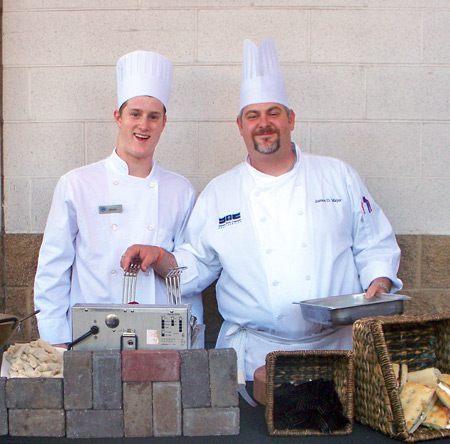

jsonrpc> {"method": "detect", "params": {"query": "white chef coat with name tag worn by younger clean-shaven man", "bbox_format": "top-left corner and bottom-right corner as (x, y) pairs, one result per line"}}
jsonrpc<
(34, 151), (203, 343)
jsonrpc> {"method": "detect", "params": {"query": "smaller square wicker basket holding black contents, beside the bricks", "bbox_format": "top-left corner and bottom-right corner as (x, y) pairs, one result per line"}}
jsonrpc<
(265, 351), (354, 436)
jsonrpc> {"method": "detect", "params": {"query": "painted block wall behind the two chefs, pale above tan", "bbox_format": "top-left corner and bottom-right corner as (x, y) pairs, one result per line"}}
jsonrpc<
(0, 0), (450, 340)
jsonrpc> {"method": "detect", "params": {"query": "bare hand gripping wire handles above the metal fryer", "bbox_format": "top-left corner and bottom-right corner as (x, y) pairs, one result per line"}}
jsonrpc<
(120, 244), (178, 277)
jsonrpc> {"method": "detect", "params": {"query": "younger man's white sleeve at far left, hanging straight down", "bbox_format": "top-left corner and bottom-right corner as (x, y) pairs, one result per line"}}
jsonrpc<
(34, 177), (78, 344)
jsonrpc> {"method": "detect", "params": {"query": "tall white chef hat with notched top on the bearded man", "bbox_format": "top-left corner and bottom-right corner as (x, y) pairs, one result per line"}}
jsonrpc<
(240, 38), (289, 110)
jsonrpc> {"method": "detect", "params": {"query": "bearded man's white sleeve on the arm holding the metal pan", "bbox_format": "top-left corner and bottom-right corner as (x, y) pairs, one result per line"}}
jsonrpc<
(347, 166), (403, 292)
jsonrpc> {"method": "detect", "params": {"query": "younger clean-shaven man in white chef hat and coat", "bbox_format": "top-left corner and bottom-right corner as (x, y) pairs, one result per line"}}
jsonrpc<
(34, 51), (202, 344)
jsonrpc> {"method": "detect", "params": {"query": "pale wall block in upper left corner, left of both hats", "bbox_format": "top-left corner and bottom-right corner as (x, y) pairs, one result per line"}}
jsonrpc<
(2, 11), (84, 65)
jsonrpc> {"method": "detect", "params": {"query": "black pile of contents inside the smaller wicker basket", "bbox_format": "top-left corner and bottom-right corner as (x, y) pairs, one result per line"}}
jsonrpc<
(273, 379), (349, 433)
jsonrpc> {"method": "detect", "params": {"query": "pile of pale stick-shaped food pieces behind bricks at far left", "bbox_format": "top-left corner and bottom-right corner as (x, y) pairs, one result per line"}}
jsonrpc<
(4, 339), (63, 378)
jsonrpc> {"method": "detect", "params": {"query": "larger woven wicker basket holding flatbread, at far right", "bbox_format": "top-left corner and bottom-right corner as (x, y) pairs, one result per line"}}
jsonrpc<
(353, 314), (450, 442)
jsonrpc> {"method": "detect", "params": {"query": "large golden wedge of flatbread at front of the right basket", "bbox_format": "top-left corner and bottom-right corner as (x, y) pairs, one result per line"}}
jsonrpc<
(400, 381), (437, 433)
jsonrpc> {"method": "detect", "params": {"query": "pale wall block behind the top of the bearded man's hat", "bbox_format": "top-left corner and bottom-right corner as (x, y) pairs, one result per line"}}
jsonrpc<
(198, 8), (309, 62)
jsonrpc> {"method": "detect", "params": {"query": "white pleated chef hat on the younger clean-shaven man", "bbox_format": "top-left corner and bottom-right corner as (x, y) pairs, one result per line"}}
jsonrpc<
(116, 51), (173, 109)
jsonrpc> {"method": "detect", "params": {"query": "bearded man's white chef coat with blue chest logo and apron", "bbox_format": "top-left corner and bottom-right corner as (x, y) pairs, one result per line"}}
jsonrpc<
(175, 146), (402, 380)
